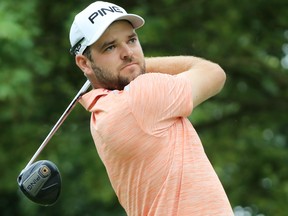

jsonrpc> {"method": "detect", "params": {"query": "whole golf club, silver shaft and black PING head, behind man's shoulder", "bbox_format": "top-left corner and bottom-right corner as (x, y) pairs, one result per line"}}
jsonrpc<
(17, 80), (91, 206)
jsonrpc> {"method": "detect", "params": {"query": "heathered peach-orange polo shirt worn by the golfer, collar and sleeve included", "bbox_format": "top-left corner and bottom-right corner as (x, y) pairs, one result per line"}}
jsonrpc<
(80, 73), (233, 216)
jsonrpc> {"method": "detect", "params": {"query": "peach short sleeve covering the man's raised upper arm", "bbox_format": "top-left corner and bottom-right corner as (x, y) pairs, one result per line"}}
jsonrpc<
(125, 73), (193, 135)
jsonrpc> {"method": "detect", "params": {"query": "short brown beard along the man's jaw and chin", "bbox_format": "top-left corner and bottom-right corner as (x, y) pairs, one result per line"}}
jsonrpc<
(91, 58), (146, 90)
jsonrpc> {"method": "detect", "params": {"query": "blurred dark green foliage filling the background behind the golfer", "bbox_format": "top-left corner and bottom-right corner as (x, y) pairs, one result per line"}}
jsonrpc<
(0, 0), (288, 216)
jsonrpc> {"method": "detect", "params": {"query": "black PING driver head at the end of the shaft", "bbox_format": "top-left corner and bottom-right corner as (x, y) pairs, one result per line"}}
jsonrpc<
(17, 160), (61, 206)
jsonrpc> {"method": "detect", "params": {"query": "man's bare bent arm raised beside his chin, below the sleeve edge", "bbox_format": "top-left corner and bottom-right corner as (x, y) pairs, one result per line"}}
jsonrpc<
(145, 56), (226, 107)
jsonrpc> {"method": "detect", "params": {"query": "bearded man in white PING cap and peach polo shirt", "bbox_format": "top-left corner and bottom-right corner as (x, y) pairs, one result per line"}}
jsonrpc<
(70, 2), (233, 216)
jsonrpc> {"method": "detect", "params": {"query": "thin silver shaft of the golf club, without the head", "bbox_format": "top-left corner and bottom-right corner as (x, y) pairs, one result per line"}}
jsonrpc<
(25, 80), (90, 168)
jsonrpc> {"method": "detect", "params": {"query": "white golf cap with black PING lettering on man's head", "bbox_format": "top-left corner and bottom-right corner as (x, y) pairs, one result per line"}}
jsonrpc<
(69, 1), (145, 55)
